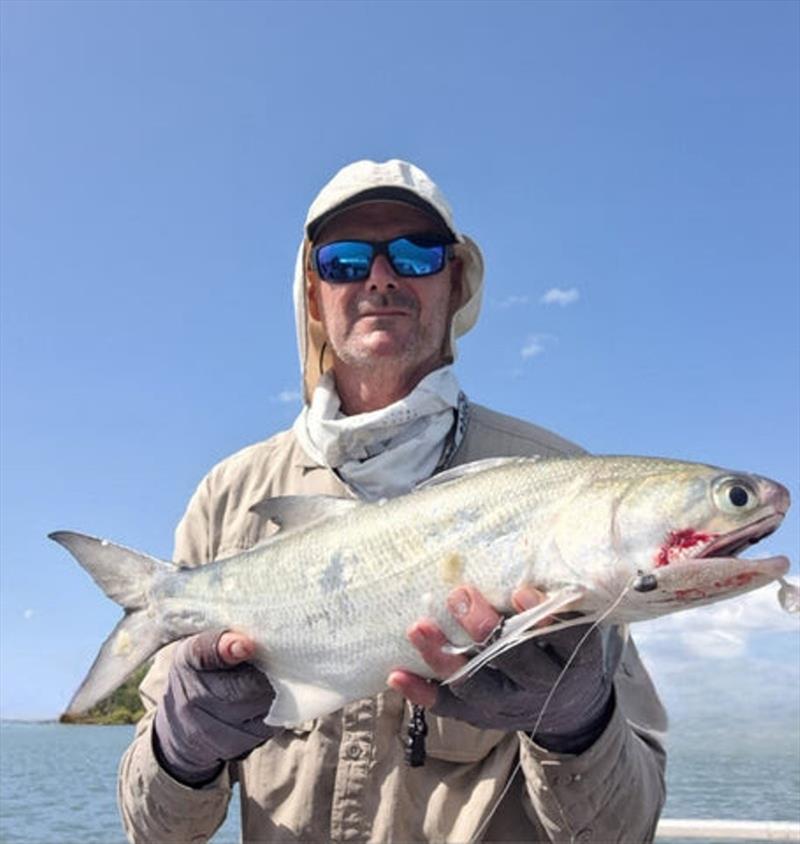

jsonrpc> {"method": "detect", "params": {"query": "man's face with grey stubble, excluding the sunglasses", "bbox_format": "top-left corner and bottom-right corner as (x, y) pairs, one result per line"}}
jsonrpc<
(308, 202), (461, 378)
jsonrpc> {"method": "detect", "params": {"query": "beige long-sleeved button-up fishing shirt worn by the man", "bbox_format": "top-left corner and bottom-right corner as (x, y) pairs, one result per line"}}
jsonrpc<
(119, 405), (666, 844)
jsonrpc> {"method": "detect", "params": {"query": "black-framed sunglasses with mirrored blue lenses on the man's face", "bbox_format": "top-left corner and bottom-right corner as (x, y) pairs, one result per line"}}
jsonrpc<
(312, 234), (454, 283)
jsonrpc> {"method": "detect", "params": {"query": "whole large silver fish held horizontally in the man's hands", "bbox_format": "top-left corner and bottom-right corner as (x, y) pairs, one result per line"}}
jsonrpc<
(51, 457), (798, 725)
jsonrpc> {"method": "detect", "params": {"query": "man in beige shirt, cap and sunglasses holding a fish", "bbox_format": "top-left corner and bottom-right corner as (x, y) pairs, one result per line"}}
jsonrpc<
(119, 161), (664, 842)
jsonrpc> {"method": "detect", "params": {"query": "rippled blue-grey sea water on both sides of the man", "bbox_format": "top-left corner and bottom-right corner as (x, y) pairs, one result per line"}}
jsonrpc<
(0, 719), (800, 844)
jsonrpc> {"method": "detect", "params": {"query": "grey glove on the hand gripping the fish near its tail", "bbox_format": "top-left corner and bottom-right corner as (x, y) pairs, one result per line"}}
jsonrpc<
(153, 630), (277, 787)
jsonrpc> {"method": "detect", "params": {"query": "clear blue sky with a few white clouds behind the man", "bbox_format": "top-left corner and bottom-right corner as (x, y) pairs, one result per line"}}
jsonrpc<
(0, 0), (800, 744)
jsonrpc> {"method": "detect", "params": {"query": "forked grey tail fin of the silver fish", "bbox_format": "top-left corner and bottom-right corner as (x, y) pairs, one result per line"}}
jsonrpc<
(50, 531), (172, 715)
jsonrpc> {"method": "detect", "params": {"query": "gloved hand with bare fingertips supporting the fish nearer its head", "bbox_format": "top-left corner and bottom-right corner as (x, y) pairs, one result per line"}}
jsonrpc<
(388, 586), (621, 753)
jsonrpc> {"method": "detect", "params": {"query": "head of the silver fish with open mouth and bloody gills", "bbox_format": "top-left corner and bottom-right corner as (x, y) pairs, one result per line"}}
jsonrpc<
(617, 464), (790, 620)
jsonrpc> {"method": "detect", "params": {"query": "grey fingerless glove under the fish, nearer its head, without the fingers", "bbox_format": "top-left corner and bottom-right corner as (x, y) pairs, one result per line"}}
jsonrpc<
(431, 625), (622, 753)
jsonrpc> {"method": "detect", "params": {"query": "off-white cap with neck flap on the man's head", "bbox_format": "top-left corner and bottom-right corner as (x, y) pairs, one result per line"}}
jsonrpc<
(294, 158), (483, 402)
